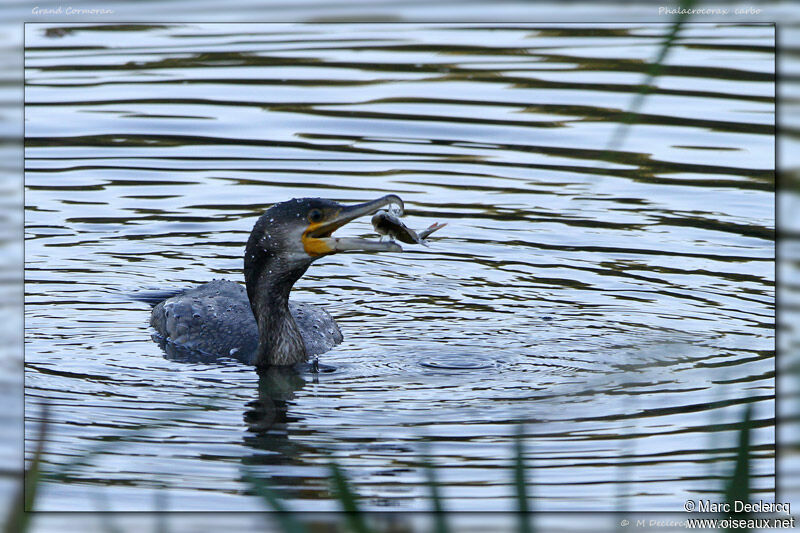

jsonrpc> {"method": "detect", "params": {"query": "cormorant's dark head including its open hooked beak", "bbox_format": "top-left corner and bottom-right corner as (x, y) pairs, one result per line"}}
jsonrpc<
(245, 194), (403, 269)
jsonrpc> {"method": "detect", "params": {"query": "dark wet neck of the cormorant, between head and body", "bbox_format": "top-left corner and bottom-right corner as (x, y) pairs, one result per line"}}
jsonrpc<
(244, 244), (308, 367)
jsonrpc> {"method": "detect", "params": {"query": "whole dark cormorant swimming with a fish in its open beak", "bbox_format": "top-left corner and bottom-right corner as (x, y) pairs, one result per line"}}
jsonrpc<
(150, 194), (403, 367)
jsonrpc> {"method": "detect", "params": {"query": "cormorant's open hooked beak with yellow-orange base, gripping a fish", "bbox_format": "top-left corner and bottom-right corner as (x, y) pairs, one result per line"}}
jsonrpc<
(302, 194), (404, 257)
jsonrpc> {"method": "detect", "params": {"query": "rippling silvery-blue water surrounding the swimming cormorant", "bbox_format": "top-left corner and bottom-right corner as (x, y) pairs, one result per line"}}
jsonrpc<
(25, 24), (775, 511)
